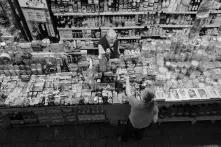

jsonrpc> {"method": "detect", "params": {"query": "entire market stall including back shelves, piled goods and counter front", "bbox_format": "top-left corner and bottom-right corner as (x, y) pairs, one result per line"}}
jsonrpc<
(0, 0), (221, 126)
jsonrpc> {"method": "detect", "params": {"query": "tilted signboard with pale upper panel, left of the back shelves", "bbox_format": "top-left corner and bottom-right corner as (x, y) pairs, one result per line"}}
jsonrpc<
(18, 0), (55, 40)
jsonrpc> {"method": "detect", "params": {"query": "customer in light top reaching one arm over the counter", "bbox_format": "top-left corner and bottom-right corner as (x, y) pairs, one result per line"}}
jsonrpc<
(119, 76), (158, 141)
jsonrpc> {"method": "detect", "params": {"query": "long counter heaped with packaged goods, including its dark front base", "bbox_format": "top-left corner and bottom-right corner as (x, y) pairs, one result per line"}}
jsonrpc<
(0, 33), (221, 126)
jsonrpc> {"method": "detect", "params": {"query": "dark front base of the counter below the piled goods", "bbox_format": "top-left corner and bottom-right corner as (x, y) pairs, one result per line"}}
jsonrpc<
(0, 99), (221, 127)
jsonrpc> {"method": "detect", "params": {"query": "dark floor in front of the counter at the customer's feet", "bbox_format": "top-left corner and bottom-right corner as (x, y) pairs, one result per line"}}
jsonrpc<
(0, 122), (221, 147)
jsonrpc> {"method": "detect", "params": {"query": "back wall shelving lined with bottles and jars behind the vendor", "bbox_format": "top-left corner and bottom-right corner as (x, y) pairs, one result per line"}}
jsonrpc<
(51, 0), (221, 47)
